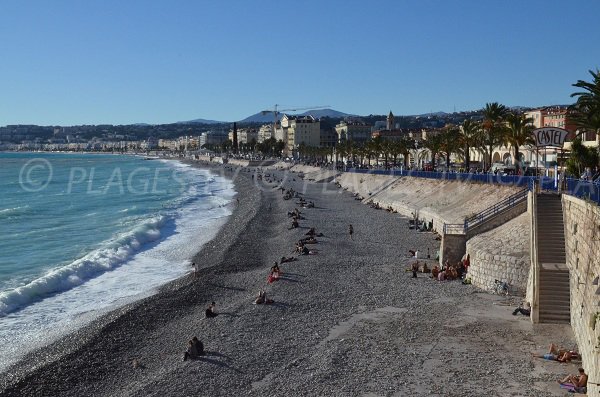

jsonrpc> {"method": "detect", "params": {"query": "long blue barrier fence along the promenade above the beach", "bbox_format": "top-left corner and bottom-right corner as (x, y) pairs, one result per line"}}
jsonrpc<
(347, 168), (600, 205)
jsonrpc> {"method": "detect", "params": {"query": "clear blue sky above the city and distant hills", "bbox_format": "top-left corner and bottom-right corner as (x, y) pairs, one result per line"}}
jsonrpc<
(0, 0), (600, 126)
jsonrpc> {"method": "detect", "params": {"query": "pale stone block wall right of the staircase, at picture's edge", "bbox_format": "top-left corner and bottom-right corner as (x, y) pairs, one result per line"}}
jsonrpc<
(562, 194), (600, 396)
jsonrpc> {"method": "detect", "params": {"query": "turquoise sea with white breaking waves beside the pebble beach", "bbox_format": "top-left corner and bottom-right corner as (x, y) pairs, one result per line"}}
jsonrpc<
(0, 153), (236, 371)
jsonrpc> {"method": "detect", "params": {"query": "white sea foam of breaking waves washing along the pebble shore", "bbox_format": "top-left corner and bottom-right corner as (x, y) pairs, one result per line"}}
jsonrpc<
(0, 162), (236, 371)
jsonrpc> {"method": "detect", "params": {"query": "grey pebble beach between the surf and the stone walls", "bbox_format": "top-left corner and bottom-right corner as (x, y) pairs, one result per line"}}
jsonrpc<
(0, 162), (571, 396)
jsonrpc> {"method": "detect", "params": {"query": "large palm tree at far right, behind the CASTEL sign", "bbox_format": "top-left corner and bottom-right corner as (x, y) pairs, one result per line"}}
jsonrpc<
(569, 69), (600, 134)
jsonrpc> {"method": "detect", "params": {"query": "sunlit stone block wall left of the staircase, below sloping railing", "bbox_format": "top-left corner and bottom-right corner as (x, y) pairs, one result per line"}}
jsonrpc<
(467, 213), (530, 296)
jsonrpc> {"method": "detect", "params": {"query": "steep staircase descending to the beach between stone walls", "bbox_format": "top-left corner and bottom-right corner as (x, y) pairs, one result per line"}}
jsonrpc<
(536, 194), (571, 324)
